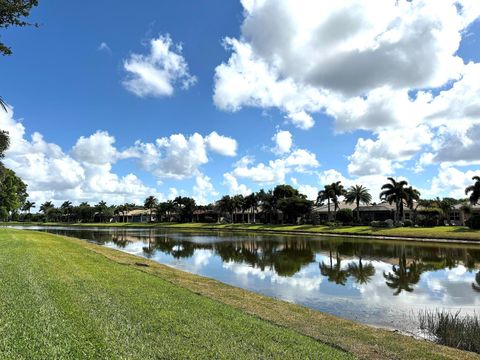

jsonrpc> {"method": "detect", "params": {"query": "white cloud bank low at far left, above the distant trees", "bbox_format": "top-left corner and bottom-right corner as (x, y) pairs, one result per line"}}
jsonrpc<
(0, 109), (162, 203)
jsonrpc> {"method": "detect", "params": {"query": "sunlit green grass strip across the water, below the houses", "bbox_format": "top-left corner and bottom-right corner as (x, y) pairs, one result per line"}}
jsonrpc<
(3, 219), (480, 241)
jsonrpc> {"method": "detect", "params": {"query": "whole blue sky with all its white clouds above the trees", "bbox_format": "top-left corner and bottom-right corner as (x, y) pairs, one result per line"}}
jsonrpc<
(0, 0), (480, 203)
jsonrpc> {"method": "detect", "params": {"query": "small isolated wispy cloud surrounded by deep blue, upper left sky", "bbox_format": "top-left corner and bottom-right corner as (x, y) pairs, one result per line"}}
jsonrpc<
(123, 34), (197, 97)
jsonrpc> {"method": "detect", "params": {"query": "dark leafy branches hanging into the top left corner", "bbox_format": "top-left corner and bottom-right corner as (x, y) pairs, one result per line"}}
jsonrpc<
(0, 0), (38, 55)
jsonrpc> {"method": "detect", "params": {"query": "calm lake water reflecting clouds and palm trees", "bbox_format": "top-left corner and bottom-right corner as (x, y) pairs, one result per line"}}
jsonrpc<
(11, 227), (480, 332)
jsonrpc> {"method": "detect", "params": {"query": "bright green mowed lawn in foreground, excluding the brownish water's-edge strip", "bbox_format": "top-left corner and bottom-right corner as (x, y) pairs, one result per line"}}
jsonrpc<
(0, 229), (354, 359)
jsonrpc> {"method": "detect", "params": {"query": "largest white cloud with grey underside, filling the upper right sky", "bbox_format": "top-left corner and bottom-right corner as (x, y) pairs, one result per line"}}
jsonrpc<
(214, 0), (480, 176)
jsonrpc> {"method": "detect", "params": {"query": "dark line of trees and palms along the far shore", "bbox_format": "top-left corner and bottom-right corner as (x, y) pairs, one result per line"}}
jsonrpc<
(10, 176), (480, 229)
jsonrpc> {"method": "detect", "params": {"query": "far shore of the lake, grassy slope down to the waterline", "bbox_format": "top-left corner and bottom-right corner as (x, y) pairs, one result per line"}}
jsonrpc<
(0, 222), (480, 244)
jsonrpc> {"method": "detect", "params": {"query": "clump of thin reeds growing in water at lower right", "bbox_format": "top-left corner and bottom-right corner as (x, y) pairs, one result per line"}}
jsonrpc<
(418, 310), (480, 353)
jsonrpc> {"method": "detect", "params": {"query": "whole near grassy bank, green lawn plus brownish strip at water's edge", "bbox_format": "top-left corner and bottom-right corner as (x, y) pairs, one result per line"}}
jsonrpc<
(0, 229), (478, 359)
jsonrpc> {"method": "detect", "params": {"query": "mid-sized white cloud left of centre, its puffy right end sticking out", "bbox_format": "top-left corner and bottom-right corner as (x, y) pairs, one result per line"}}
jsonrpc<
(132, 132), (237, 180)
